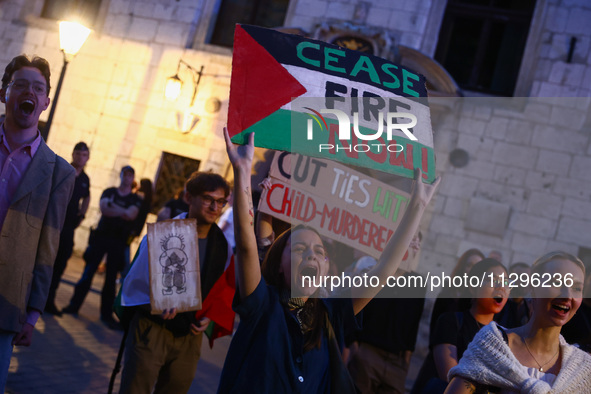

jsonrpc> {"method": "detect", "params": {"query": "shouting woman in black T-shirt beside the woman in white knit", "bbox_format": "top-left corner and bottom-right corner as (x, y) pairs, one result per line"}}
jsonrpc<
(411, 258), (509, 393)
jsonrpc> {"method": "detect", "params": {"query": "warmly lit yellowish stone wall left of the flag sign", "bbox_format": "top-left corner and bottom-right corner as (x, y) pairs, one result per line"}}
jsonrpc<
(0, 0), (236, 246)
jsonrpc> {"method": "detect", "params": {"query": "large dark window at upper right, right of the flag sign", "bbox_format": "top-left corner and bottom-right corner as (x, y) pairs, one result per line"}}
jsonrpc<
(435, 0), (535, 96)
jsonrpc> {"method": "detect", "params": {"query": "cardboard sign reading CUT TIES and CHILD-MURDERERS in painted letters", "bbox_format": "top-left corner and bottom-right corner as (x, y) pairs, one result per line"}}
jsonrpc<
(259, 152), (416, 271)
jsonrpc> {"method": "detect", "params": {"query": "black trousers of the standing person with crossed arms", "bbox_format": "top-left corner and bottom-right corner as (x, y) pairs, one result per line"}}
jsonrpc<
(70, 234), (127, 319)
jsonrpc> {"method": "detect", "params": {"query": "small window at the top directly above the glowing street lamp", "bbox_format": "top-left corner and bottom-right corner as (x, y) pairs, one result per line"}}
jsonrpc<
(41, 0), (101, 27)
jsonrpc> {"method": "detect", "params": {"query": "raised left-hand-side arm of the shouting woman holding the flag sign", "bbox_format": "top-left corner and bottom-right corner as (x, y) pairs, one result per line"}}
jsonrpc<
(224, 127), (261, 298)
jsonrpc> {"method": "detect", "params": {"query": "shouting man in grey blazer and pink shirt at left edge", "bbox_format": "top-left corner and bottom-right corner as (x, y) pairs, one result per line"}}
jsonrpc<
(0, 55), (75, 391)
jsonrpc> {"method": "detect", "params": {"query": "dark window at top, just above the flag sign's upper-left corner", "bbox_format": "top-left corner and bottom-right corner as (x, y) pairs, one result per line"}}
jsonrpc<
(206, 0), (289, 48)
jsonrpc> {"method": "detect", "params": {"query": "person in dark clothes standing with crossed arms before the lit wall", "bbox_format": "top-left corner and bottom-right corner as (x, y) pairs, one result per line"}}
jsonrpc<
(62, 166), (141, 330)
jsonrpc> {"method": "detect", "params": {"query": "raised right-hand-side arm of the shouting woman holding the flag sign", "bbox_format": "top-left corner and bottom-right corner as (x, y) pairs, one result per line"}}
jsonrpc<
(351, 168), (441, 313)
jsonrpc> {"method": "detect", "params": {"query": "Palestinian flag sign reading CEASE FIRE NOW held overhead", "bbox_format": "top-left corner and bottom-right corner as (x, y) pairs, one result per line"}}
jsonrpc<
(228, 25), (435, 182)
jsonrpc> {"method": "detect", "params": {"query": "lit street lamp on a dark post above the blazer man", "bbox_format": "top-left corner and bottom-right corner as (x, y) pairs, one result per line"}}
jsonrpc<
(41, 22), (91, 141)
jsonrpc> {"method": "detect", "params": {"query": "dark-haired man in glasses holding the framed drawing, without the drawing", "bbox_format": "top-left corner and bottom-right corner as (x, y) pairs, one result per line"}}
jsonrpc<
(119, 172), (234, 393)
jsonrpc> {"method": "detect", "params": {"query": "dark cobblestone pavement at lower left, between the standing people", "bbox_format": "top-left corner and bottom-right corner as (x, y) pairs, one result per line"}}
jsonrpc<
(5, 257), (230, 394)
